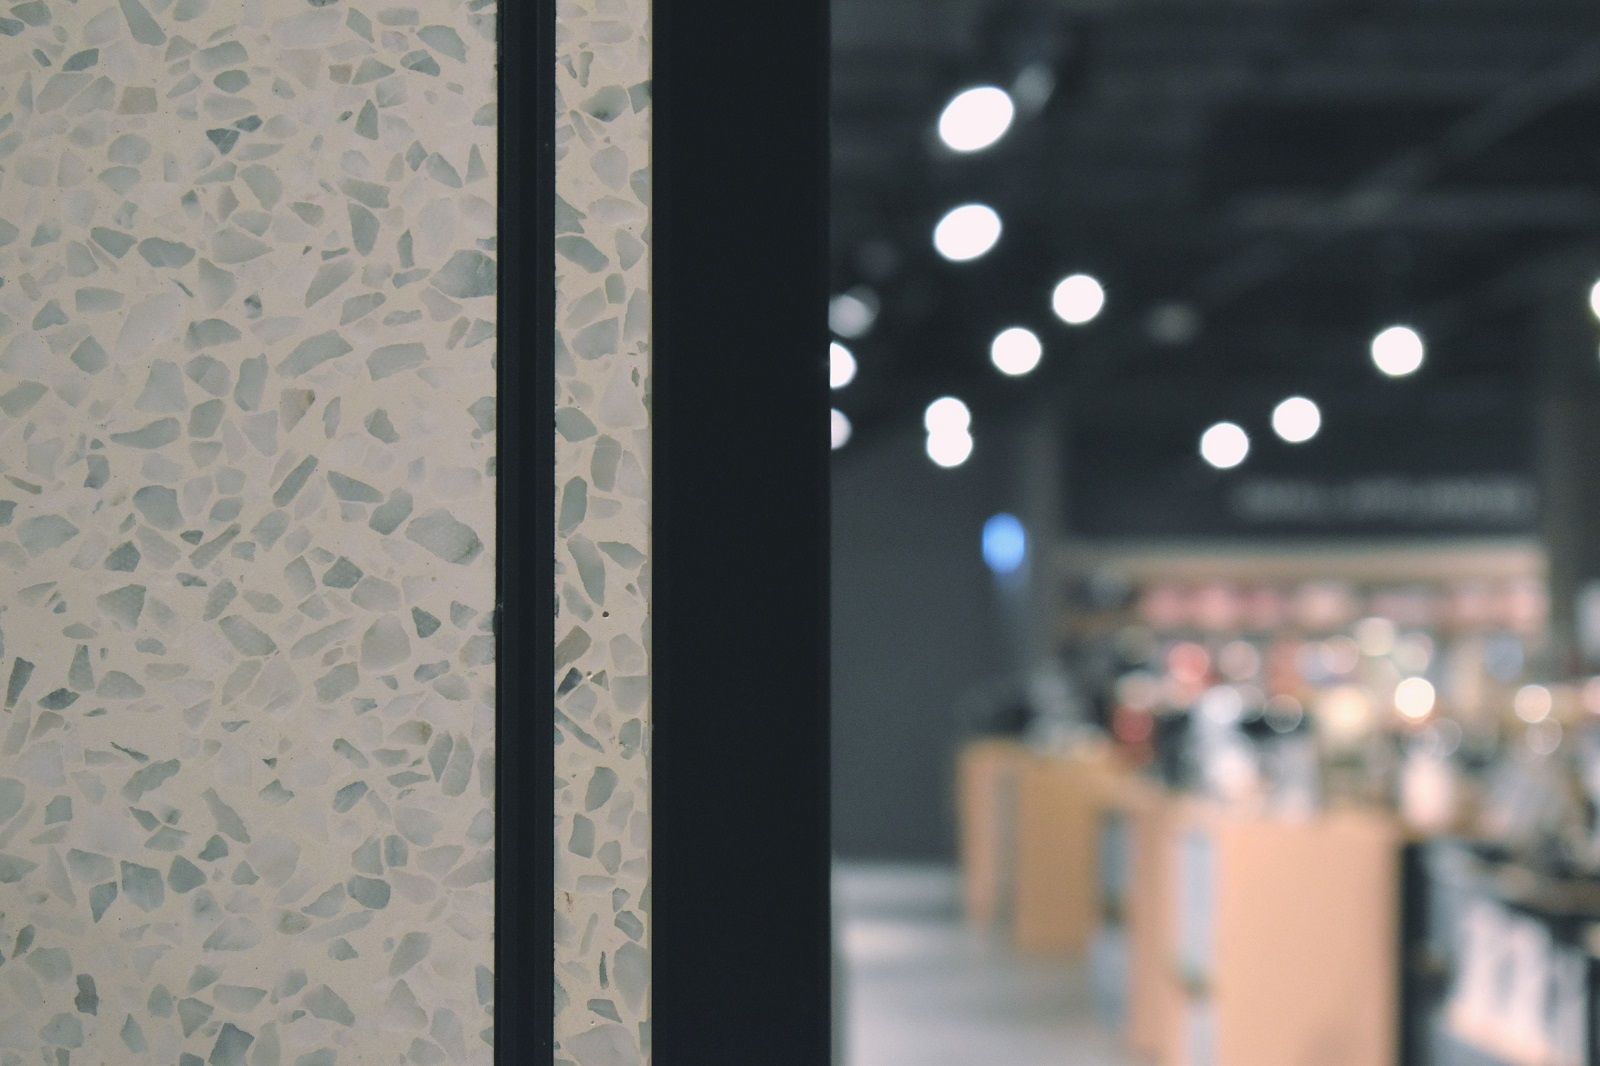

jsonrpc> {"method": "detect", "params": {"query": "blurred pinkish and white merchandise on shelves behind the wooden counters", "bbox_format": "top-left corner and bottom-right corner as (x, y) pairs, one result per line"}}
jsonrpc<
(1062, 560), (1600, 860)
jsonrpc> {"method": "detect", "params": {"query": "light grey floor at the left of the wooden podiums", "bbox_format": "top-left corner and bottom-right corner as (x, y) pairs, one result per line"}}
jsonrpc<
(834, 864), (1133, 1066)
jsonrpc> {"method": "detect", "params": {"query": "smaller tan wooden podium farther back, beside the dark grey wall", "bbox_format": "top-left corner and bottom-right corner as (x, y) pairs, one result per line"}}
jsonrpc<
(958, 741), (1115, 954)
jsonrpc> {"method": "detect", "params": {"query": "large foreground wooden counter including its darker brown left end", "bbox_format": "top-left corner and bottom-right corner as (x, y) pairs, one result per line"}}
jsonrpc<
(1093, 793), (1405, 1066)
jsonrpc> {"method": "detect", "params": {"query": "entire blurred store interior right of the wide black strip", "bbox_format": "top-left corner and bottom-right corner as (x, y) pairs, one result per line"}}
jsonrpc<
(829, 0), (1600, 1066)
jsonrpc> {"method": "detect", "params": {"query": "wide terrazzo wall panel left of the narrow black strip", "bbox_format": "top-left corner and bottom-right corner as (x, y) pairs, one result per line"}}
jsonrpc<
(0, 0), (496, 1066)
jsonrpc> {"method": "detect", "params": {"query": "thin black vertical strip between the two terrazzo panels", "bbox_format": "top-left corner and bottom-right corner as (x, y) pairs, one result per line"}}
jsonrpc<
(494, 0), (555, 1049)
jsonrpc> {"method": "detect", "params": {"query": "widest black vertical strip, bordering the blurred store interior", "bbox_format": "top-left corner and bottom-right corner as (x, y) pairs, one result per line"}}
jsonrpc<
(651, 0), (830, 1066)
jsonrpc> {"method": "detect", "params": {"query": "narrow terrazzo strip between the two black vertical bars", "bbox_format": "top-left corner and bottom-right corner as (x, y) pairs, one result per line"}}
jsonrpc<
(555, 0), (651, 1066)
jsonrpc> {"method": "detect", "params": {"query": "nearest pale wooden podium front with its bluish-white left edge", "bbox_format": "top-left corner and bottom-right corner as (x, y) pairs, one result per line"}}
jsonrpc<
(1144, 800), (1403, 1066)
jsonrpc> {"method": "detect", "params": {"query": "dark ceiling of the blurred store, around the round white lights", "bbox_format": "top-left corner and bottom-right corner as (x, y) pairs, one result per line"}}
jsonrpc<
(832, 0), (1600, 459)
